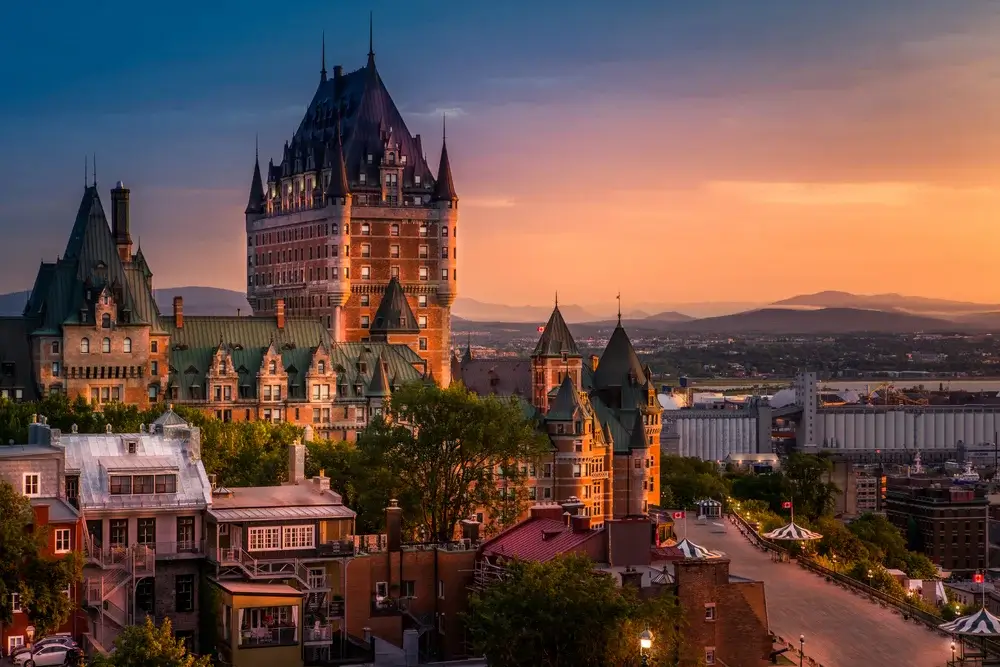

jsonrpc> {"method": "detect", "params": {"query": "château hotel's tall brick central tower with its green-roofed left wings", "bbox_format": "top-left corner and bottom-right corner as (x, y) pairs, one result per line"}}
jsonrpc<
(0, 39), (458, 440)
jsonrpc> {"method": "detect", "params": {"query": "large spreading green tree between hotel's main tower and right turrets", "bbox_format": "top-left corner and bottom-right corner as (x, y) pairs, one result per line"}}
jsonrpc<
(358, 383), (550, 541)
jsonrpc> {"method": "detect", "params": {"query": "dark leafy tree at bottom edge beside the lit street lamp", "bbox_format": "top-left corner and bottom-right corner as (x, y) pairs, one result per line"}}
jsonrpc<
(465, 554), (680, 667)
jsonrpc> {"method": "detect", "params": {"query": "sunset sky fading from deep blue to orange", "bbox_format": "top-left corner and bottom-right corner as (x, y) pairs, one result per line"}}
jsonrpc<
(0, 0), (1000, 305)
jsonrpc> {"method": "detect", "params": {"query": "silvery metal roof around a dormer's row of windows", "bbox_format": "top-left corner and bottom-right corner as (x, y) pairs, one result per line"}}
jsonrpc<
(61, 433), (212, 512)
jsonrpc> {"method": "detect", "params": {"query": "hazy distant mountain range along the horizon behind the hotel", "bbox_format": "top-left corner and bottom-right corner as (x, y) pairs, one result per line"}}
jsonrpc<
(0, 287), (1000, 336)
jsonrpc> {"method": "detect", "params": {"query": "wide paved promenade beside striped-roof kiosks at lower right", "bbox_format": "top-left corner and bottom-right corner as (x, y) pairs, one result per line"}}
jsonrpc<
(677, 521), (951, 667)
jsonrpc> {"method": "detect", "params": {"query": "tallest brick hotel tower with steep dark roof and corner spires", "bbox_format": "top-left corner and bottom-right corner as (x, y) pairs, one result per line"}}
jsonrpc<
(246, 30), (458, 386)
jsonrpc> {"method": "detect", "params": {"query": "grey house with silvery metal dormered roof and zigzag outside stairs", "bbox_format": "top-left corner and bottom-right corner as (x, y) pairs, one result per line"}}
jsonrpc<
(59, 411), (211, 647)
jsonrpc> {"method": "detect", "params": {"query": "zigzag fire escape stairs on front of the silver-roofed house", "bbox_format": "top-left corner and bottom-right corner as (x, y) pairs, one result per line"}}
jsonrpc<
(83, 532), (156, 642)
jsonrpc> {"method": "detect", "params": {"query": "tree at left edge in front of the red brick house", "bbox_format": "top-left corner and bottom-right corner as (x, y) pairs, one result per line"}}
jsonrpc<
(0, 480), (83, 637)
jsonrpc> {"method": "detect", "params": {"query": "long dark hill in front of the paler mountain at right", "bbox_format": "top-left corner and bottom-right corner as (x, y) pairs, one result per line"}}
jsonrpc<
(669, 308), (970, 334)
